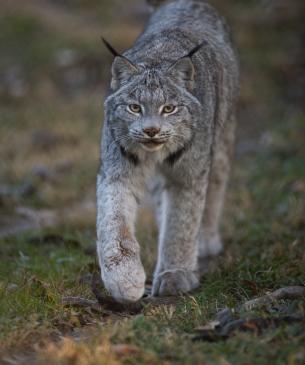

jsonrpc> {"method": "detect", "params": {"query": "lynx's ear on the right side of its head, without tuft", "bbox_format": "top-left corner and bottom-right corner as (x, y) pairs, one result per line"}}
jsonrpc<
(167, 56), (195, 88)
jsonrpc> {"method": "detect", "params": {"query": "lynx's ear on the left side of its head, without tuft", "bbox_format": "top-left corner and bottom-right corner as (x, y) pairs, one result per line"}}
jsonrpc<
(111, 55), (138, 90)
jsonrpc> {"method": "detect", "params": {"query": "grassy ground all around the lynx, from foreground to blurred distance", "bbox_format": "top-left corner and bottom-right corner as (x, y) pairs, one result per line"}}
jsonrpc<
(0, 0), (305, 365)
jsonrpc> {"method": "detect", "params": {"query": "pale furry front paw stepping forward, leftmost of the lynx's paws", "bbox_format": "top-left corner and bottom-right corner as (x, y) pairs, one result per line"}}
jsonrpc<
(101, 245), (146, 303)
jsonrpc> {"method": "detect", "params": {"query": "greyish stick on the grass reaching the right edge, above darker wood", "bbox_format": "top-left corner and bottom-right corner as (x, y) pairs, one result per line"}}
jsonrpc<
(240, 286), (305, 311)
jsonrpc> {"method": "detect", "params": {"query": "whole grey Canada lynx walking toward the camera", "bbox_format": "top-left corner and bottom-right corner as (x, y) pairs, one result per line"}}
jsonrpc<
(97, 0), (238, 302)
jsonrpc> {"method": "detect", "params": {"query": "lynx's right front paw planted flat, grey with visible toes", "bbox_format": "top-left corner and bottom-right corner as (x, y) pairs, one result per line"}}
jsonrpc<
(152, 269), (199, 296)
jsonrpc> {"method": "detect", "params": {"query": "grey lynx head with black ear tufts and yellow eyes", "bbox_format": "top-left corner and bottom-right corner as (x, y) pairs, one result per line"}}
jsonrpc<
(105, 42), (201, 154)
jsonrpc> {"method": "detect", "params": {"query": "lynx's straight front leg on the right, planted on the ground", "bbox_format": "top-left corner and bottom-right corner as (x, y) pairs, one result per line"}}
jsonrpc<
(152, 184), (206, 295)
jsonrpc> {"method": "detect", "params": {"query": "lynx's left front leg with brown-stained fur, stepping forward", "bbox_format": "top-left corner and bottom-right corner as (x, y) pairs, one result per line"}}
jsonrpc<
(97, 176), (145, 302)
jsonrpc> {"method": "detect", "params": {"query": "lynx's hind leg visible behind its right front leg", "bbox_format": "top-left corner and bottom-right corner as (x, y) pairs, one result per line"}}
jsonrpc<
(199, 118), (235, 258)
